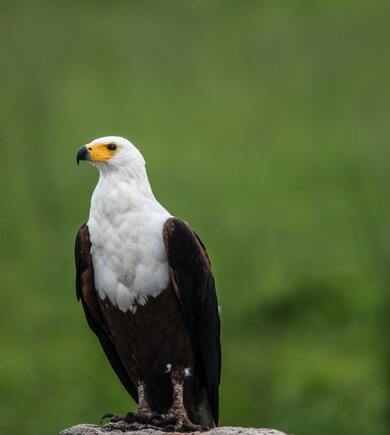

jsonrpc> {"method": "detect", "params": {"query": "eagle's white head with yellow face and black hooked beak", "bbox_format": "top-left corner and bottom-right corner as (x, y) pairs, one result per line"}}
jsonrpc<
(77, 136), (145, 170)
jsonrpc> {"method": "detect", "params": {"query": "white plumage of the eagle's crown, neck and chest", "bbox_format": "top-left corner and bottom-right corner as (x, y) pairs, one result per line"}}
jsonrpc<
(88, 137), (171, 312)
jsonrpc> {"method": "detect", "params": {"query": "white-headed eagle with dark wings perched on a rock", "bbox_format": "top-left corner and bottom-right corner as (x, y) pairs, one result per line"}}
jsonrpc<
(75, 136), (221, 431)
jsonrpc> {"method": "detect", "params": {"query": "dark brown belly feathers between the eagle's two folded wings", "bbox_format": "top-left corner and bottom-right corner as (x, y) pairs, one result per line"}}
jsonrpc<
(99, 287), (204, 422)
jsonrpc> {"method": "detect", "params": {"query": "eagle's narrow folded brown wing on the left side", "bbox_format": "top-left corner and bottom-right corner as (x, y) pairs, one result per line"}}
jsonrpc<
(75, 225), (138, 402)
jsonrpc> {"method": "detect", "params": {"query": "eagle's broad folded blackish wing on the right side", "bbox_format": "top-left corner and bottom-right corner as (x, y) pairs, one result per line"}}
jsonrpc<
(164, 218), (221, 425)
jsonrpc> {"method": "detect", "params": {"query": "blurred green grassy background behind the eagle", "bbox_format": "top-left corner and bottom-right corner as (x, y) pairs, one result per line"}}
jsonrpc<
(0, 0), (390, 435)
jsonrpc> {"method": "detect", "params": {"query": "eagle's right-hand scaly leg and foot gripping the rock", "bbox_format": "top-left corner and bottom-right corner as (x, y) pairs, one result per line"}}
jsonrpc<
(160, 369), (203, 432)
